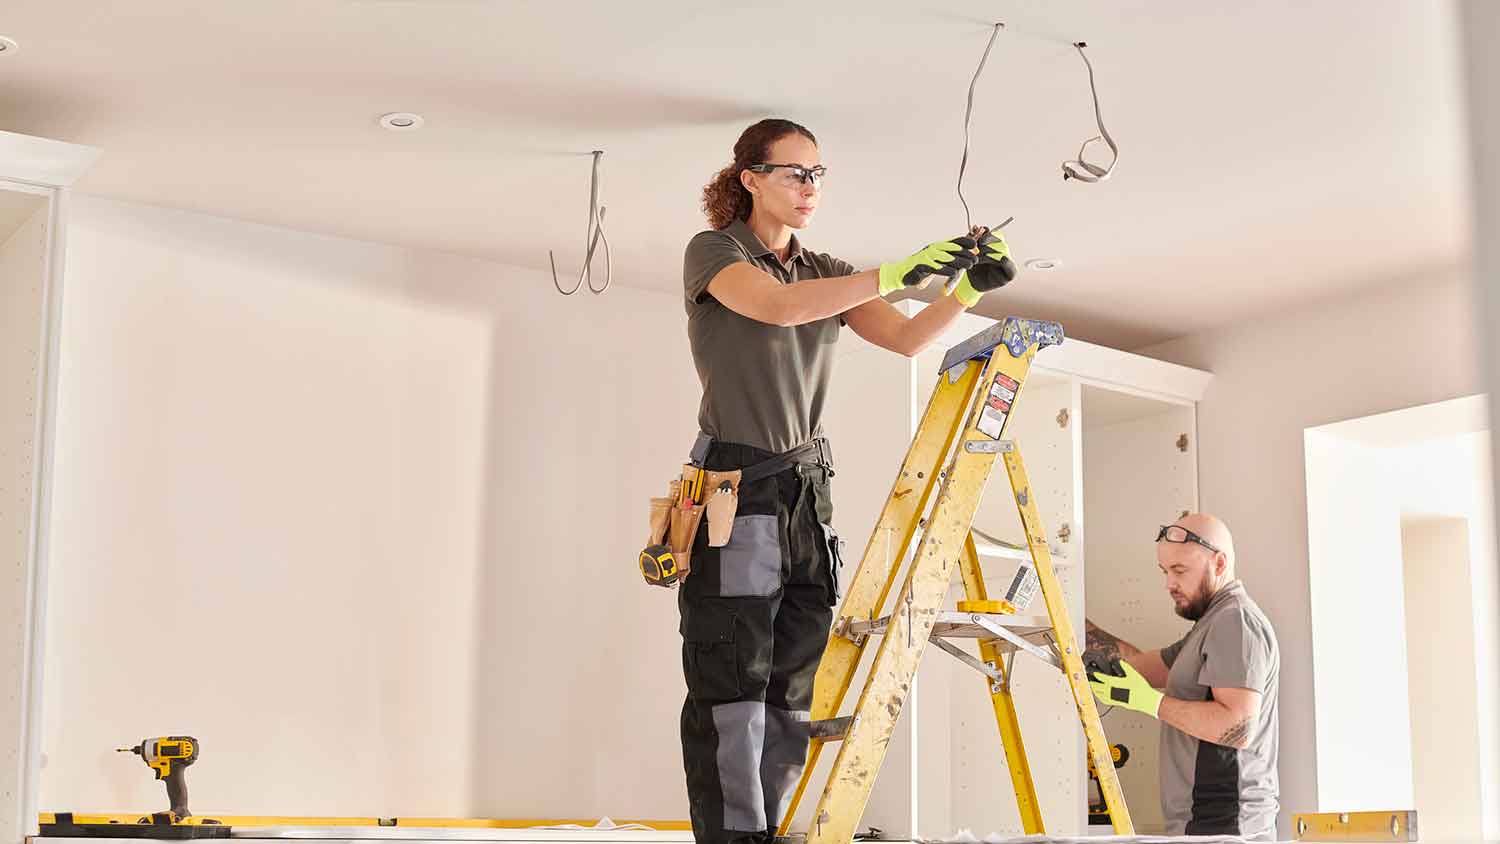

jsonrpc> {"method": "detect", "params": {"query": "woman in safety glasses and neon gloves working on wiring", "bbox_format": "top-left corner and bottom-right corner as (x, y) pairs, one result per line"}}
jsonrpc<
(678, 120), (1008, 844)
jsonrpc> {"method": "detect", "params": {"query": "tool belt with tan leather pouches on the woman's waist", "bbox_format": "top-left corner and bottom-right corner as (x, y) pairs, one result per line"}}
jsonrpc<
(639, 433), (833, 586)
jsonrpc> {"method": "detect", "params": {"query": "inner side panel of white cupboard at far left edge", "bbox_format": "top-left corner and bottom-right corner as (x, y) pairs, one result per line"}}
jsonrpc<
(0, 195), (48, 834)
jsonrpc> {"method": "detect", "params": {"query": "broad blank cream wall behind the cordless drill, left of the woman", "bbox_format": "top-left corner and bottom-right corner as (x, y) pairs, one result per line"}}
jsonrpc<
(42, 199), (698, 819)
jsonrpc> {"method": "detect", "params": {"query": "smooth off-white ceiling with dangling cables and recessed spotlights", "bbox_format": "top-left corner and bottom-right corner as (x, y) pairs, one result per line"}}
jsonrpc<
(0, 0), (1467, 348)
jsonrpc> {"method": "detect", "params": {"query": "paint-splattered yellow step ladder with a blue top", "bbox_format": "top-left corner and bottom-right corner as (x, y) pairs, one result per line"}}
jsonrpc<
(779, 316), (1134, 844)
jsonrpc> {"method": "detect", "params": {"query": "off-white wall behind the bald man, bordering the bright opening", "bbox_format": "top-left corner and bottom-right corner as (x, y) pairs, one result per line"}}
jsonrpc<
(1146, 276), (1479, 835)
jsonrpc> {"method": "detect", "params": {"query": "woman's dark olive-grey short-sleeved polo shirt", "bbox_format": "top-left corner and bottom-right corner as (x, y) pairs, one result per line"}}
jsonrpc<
(683, 220), (855, 454)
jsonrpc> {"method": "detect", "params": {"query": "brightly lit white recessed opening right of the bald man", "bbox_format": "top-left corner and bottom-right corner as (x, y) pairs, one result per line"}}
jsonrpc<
(1307, 425), (1500, 840)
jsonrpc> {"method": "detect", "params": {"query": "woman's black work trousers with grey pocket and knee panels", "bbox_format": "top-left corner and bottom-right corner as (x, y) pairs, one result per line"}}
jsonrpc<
(678, 442), (840, 844)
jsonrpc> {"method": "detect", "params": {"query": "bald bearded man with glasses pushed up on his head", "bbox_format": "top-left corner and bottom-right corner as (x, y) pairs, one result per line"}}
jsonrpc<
(1088, 513), (1281, 841)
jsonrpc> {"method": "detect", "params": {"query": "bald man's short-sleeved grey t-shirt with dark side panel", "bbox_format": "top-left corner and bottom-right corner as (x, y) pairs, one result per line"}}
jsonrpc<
(1161, 580), (1281, 841)
